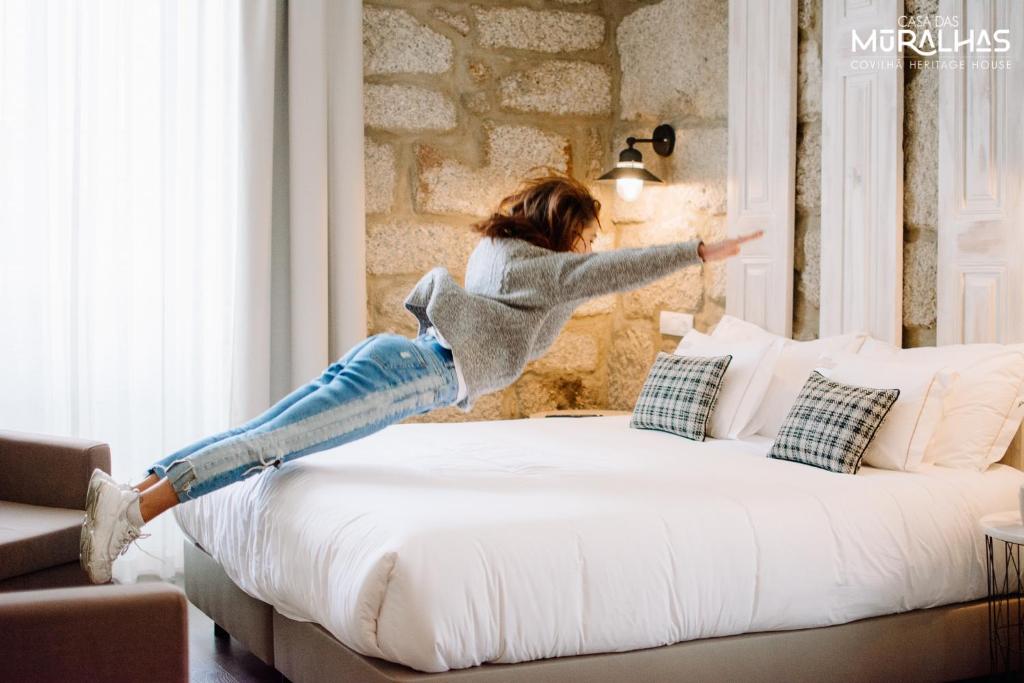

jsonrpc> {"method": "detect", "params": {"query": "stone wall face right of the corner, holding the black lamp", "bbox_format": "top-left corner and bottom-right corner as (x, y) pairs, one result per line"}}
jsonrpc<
(606, 0), (729, 410)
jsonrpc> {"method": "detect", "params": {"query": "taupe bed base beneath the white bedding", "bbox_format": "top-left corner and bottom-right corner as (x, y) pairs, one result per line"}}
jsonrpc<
(185, 542), (1007, 683)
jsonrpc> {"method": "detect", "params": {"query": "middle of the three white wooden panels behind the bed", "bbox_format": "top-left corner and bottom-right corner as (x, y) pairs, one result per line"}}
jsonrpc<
(819, 0), (903, 345)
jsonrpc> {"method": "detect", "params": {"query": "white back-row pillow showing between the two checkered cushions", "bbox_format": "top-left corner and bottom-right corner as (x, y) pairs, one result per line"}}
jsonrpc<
(712, 315), (865, 438)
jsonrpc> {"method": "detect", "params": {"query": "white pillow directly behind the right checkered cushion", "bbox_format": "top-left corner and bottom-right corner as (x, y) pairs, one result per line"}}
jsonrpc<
(818, 353), (951, 471)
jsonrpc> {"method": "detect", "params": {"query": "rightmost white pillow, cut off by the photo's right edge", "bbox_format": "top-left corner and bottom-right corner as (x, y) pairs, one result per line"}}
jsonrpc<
(860, 340), (1024, 470)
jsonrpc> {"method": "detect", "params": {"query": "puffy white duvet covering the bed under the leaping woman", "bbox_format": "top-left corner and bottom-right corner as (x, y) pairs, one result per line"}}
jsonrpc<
(177, 417), (1024, 672)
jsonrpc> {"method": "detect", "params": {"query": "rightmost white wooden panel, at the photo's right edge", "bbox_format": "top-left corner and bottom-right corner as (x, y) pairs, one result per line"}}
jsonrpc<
(936, 0), (1024, 344)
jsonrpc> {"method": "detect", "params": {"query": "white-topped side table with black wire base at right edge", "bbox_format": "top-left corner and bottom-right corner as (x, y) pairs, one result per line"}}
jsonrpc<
(979, 510), (1024, 673)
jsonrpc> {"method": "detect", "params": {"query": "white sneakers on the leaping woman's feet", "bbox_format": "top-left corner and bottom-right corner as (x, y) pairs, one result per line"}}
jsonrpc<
(79, 470), (141, 584)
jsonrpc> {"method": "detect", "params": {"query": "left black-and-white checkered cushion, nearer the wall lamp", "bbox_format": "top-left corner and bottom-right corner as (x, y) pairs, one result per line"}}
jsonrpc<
(630, 353), (732, 441)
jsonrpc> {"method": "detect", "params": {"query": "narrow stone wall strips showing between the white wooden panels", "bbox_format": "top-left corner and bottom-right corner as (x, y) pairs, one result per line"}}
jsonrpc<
(793, 0), (939, 346)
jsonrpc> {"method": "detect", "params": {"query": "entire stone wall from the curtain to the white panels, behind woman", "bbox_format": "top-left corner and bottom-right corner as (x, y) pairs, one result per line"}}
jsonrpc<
(364, 0), (728, 420)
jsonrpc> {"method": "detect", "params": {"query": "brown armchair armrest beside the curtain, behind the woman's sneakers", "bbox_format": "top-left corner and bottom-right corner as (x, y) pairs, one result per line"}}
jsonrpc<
(0, 430), (111, 510)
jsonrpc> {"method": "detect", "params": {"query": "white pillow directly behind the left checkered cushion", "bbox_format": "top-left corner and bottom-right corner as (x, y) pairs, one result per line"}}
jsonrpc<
(676, 330), (781, 438)
